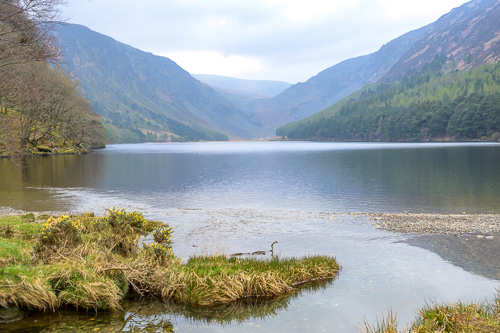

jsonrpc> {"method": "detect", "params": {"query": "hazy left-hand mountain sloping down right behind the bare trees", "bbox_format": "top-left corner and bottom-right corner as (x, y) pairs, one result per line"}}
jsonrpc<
(57, 24), (259, 141)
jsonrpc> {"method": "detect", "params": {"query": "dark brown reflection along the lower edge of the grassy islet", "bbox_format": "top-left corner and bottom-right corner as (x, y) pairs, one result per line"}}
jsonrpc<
(0, 281), (331, 333)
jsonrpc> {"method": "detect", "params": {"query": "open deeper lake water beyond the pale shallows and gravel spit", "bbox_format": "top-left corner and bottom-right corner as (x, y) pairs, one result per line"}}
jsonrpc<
(0, 142), (500, 213)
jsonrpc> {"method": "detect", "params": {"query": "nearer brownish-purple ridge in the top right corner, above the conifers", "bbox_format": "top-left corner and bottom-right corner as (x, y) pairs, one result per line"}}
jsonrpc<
(383, 0), (500, 81)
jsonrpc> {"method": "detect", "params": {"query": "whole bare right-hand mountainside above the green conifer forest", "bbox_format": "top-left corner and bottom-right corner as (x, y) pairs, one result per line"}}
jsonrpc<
(253, 0), (500, 134)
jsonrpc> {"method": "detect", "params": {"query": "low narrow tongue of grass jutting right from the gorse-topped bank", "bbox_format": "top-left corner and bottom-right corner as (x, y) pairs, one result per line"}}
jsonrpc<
(126, 255), (340, 306)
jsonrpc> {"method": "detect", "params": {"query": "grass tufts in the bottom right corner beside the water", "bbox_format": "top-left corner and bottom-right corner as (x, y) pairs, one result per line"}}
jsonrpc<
(359, 292), (500, 333)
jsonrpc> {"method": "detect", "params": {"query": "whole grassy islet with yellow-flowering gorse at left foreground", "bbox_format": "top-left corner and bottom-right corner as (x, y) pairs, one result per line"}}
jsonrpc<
(0, 209), (340, 323)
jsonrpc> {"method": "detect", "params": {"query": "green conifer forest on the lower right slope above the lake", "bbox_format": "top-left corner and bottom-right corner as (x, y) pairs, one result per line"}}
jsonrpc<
(277, 63), (500, 141)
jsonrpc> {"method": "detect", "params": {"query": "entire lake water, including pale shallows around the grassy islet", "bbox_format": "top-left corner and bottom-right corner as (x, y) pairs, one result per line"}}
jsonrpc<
(0, 142), (500, 332)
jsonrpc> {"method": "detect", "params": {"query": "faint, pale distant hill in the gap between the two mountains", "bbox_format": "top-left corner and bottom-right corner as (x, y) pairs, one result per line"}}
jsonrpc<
(192, 74), (291, 99)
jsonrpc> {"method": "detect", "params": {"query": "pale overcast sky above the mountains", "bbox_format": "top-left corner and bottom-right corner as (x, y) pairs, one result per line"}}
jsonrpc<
(63, 0), (467, 83)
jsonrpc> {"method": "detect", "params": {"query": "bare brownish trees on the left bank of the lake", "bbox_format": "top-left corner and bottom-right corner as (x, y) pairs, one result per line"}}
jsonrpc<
(0, 0), (105, 156)
